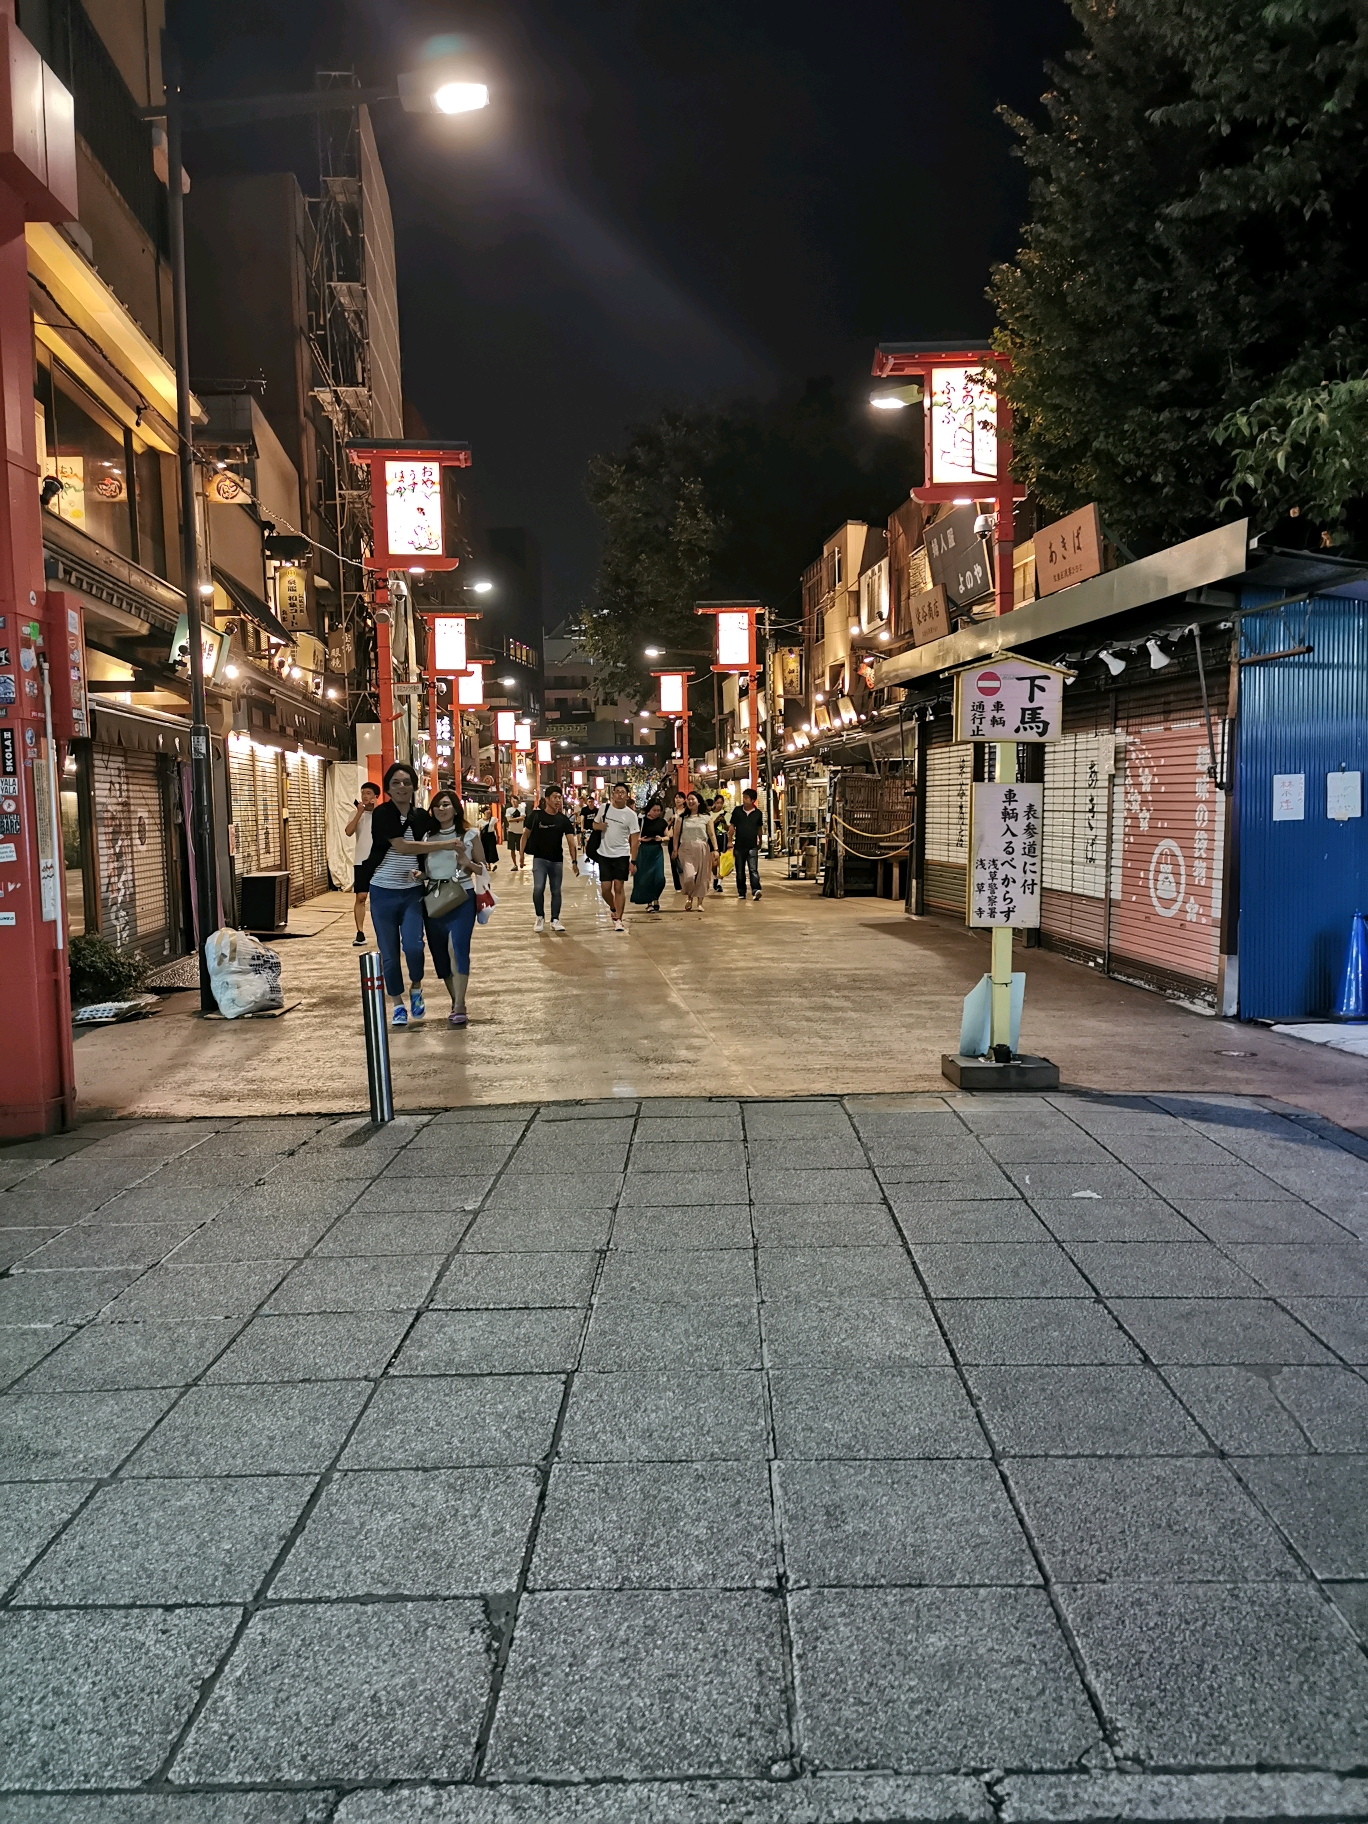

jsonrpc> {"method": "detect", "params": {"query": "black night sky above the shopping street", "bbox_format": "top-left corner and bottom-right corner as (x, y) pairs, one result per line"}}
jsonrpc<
(171, 0), (1071, 620)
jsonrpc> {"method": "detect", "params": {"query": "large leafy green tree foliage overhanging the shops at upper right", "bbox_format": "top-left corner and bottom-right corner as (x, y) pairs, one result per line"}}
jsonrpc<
(992, 0), (1368, 547)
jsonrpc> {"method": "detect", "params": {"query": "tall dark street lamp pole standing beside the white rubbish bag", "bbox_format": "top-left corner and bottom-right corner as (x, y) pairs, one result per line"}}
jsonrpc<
(162, 31), (219, 1014)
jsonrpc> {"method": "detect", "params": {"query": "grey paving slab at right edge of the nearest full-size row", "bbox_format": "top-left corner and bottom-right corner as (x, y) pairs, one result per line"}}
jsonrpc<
(1060, 1583), (1368, 1771)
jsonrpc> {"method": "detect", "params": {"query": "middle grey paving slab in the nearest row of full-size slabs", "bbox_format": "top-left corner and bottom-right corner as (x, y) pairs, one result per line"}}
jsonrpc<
(487, 1591), (790, 1780)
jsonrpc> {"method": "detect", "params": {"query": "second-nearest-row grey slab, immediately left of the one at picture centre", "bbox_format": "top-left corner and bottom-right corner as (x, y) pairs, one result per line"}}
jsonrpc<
(270, 1468), (540, 1600)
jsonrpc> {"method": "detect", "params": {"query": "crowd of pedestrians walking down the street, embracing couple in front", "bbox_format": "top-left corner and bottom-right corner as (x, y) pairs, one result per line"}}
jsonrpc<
(347, 761), (764, 1027)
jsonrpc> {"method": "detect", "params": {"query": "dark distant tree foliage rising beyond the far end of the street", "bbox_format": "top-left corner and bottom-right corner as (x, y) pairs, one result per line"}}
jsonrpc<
(584, 379), (916, 697)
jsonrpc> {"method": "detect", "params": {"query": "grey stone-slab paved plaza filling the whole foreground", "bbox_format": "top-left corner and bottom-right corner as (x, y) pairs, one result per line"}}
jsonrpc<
(0, 1094), (1368, 1824)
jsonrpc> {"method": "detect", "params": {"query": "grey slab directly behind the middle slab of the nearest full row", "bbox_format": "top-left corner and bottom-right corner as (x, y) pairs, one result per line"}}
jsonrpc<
(529, 1461), (779, 1591)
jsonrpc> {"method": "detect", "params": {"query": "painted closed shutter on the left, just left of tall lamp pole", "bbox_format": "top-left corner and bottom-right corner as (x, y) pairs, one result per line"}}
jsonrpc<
(93, 742), (171, 956)
